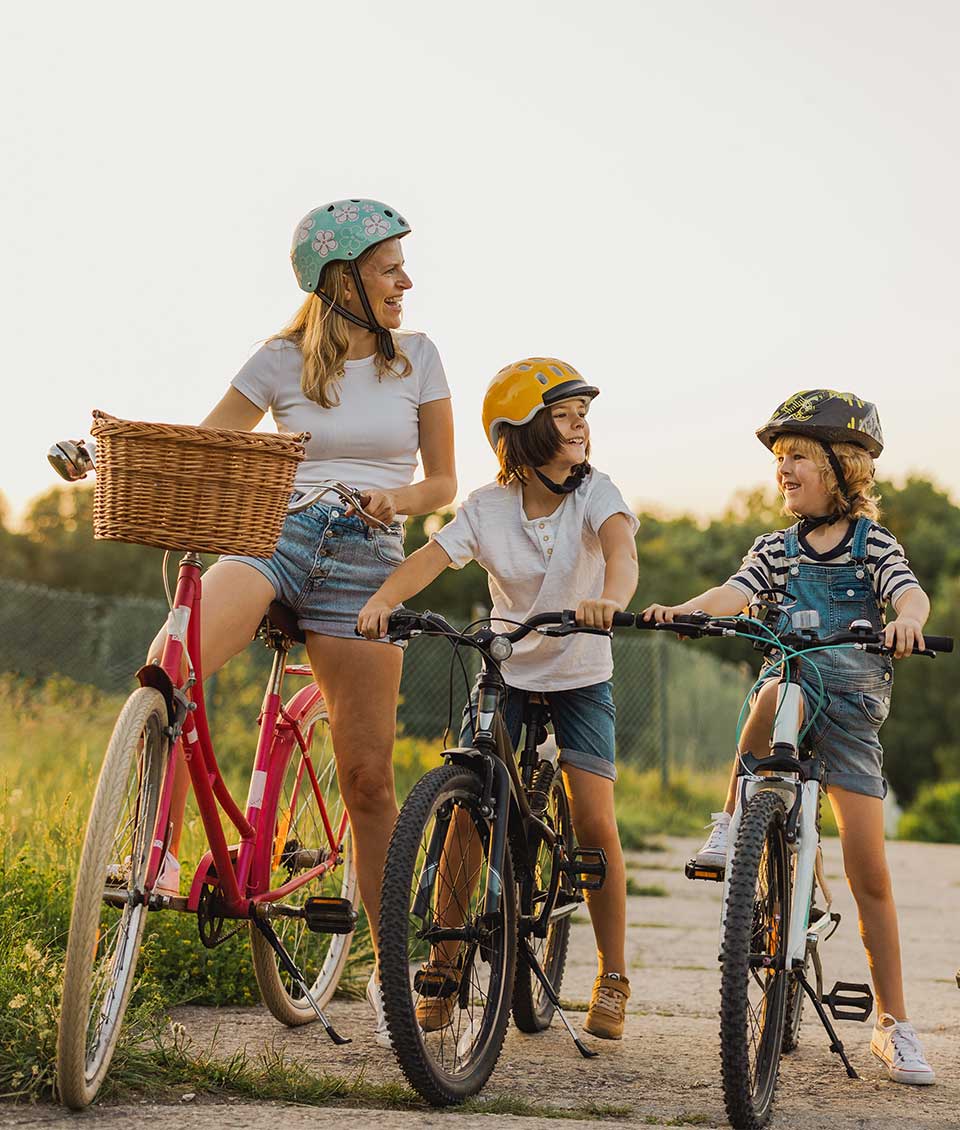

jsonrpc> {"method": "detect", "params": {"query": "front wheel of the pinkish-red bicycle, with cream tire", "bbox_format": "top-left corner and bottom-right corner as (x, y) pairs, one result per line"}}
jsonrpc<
(56, 687), (168, 1110)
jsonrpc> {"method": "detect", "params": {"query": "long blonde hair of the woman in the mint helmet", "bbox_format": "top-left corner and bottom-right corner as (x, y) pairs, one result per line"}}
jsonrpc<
(268, 244), (413, 408)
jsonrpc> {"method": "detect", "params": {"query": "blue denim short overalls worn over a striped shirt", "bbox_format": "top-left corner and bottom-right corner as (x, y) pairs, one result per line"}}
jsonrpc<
(765, 518), (893, 797)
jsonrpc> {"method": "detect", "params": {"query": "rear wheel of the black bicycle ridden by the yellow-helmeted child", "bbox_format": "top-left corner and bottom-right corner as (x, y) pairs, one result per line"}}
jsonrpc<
(513, 772), (574, 1032)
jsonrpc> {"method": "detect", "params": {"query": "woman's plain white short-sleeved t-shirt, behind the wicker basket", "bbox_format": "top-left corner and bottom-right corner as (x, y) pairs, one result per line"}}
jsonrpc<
(230, 332), (450, 490)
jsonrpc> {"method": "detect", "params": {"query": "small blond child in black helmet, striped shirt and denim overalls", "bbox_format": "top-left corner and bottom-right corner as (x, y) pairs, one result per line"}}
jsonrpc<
(643, 389), (934, 1084)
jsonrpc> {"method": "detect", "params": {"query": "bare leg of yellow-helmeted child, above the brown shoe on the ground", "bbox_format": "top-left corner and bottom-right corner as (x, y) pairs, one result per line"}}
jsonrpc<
(564, 765), (627, 976)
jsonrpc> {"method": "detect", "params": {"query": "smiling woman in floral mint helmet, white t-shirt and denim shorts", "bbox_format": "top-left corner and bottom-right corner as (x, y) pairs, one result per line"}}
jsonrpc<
(151, 199), (456, 1043)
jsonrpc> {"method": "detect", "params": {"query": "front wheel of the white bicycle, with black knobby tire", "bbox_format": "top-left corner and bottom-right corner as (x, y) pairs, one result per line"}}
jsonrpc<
(721, 789), (791, 1130)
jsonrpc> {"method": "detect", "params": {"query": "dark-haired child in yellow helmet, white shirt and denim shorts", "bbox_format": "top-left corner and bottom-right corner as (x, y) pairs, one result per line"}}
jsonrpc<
(358, 357), (638, 1040)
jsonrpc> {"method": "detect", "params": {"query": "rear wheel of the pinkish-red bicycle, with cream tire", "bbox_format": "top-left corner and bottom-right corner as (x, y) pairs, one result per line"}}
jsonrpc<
(250, 701), (360, 1027)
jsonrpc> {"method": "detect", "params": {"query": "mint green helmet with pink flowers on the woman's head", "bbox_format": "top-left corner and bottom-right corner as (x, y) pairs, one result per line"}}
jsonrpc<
(290, 199), (410, 294)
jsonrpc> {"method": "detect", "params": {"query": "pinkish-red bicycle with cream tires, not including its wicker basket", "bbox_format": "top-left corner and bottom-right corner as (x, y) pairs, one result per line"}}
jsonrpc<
(51, 429), (376, 1109)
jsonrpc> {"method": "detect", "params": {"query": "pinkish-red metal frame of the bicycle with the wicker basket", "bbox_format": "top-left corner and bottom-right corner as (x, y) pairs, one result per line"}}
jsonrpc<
(137, 553), (347, 919)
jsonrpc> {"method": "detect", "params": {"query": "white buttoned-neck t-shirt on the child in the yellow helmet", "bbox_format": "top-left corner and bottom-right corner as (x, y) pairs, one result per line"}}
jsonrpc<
(434, 470), (640, 692)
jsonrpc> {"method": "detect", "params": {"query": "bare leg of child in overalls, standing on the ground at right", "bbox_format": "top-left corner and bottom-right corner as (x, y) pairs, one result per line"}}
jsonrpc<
(828, 786), (907, 1020)
